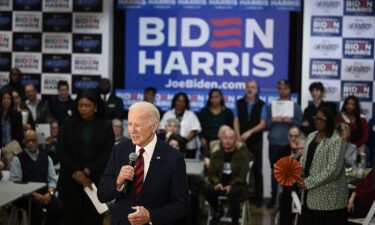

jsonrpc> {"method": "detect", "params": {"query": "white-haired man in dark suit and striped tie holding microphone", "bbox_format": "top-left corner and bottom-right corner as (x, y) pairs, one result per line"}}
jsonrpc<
(98, 102), (190, 225)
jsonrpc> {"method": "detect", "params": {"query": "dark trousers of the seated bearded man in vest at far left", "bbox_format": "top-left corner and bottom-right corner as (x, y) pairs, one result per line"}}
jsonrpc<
(15, 197), (63, 225)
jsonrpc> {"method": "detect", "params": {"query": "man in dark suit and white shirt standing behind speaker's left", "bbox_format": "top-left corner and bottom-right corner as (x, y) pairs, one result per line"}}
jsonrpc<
(99, 78), (125, 120)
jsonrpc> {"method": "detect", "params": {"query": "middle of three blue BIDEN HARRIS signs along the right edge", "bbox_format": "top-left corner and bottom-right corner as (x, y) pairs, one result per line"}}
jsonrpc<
(343, 38), (374, 59)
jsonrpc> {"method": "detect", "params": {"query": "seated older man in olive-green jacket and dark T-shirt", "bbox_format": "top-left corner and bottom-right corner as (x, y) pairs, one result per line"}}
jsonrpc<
(205, 129), (250, 225)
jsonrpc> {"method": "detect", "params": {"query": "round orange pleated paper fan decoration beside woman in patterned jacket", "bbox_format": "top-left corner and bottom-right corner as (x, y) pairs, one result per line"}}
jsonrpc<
(273, 156), (302, 187)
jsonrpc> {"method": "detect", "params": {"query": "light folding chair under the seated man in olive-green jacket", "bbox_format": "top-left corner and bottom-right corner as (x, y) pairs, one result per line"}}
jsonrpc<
(207, 161), (254, 225)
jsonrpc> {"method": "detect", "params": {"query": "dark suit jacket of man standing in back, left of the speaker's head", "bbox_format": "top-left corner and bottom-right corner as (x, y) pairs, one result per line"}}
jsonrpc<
(104, 92), (125, 120)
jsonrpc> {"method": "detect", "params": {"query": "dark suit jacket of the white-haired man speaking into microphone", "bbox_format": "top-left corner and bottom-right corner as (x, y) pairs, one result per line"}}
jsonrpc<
(98, 139), (190, 225)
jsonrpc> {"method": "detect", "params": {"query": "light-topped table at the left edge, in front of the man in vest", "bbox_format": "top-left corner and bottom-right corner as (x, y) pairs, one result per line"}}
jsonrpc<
(0, 181), (47, 224)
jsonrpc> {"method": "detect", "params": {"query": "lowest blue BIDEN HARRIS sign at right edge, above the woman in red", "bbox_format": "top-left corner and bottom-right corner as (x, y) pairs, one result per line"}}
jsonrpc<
(341, 81), (373, 101)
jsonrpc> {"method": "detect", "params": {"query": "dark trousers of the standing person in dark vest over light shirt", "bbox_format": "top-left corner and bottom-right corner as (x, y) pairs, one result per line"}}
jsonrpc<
(246, 141), (263, 201)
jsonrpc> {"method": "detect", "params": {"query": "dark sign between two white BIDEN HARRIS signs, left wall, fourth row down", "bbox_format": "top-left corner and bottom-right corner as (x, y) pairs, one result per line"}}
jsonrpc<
(42, 54), (72, 73)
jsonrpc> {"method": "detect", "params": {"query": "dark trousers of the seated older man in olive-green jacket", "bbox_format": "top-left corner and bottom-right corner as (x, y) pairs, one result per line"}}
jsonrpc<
(204, 184), (241, 224)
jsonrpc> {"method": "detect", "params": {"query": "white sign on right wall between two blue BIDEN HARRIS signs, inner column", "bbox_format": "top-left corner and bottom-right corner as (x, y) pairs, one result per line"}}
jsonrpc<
(310, 37), (342, 59)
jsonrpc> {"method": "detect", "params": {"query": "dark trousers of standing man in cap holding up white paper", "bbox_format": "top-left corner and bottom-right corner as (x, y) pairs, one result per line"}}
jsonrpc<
(268, 144), (290, 200)
